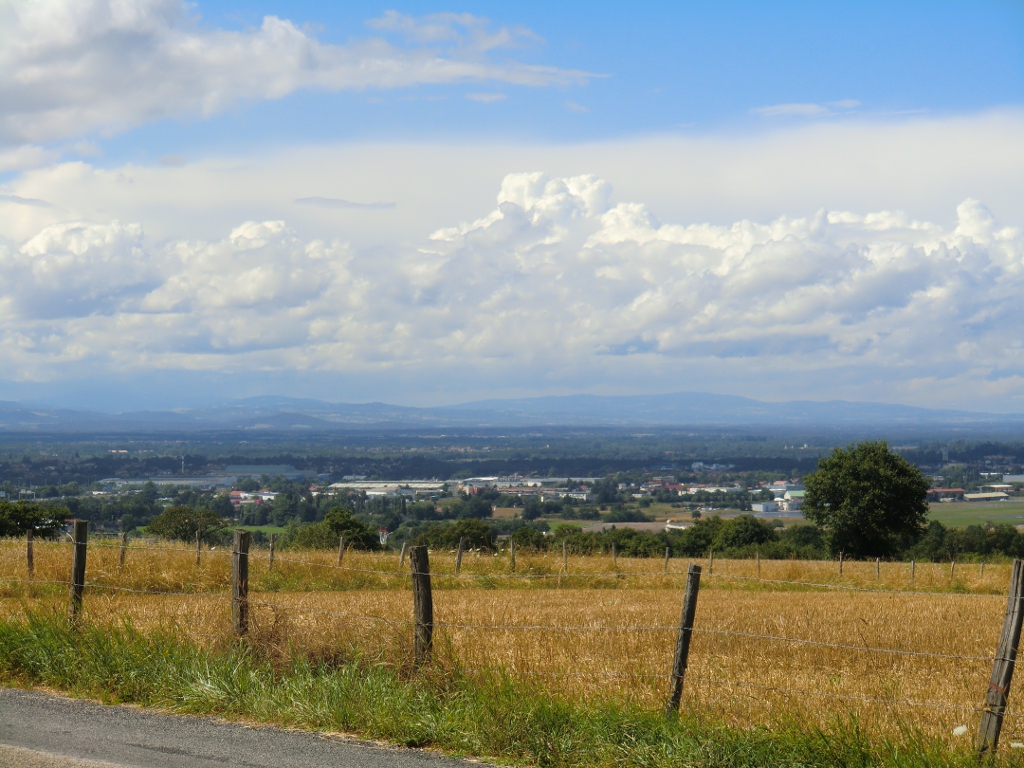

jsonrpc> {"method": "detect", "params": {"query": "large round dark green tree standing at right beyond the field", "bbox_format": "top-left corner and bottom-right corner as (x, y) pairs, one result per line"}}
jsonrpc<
(803, 440), (928, 557)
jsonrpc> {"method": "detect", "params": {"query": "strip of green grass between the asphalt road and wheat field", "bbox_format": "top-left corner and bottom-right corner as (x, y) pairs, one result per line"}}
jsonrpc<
(0, 612), (1011, 768)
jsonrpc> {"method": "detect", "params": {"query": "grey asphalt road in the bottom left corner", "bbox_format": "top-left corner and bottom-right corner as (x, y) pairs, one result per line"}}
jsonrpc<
(0, 689), (469, 768)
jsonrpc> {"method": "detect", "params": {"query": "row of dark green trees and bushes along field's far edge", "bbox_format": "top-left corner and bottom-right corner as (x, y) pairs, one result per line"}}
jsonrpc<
(6, 441), (1024, 560)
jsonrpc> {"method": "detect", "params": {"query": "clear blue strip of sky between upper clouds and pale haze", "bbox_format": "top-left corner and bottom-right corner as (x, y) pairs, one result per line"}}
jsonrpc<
(70, 1), (1024, 163)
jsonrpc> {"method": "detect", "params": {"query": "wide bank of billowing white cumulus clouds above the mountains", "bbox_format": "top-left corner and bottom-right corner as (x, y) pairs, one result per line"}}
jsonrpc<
(0, 173), (1024, 407)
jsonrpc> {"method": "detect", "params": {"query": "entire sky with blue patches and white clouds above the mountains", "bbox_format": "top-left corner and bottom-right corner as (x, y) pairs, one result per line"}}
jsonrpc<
(0, 0), (1024, 411)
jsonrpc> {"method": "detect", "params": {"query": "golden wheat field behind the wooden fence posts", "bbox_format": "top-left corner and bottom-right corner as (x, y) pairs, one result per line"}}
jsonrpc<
(0, 541), (1024, 741)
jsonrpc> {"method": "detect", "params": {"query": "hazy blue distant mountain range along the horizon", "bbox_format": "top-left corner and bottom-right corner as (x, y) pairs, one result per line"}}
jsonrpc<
(0, 392), (1011, 432)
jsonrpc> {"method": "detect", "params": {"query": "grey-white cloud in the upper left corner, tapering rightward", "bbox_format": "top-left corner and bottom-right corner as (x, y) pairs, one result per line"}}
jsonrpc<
(0, 0), (592, 144)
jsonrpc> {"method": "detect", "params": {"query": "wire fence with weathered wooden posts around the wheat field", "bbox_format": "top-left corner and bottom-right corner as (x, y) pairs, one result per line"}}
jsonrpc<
(0, 520), (1024, 756)
